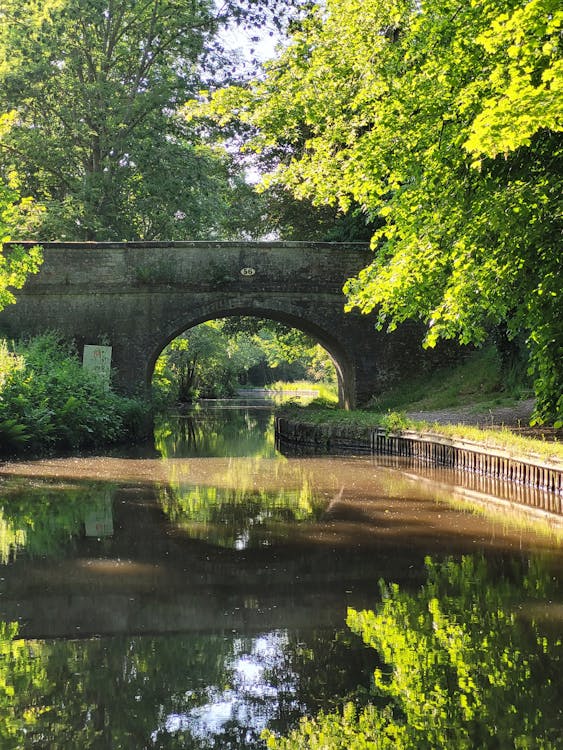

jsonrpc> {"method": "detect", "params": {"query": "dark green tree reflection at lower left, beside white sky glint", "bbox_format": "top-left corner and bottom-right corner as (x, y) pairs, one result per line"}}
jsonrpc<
(0, 623), (235, 750)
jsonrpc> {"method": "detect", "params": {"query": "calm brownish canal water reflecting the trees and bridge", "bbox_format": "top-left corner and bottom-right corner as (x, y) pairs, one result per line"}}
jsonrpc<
(0, 405), (563, 750)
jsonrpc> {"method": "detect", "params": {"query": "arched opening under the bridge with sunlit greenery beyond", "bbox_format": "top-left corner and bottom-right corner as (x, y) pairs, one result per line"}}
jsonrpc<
(147, 309), (353, 408)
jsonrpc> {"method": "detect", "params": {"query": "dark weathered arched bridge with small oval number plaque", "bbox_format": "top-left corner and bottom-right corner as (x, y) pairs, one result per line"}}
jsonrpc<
(0, 242), (429, 408)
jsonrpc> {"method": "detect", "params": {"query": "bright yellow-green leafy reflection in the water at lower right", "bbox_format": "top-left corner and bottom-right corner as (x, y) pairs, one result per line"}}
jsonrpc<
(265, 556), (563, 750)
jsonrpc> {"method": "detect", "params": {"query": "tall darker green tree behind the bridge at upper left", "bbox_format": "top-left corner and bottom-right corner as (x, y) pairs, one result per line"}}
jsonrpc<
(0, 0), (308, 240)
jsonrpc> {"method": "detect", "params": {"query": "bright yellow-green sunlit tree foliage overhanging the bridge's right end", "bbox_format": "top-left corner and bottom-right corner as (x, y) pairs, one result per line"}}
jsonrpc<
(198, 0), (563, 421)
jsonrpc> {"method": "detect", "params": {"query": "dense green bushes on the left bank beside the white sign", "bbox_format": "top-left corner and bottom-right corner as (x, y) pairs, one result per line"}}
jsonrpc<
(0, 334), (148, 453)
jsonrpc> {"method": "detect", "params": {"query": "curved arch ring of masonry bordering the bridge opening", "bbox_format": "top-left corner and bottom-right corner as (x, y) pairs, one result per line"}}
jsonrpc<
(145, 304), (354, 407)
